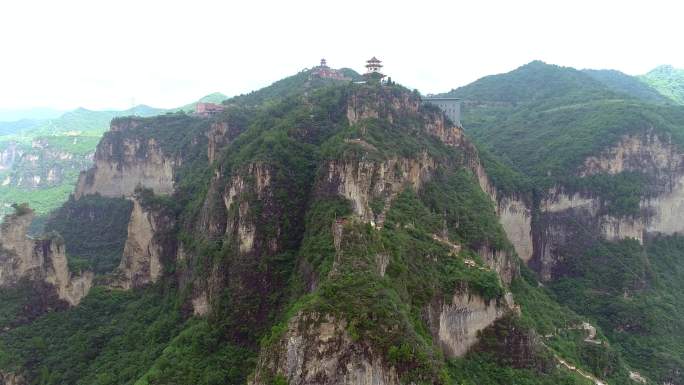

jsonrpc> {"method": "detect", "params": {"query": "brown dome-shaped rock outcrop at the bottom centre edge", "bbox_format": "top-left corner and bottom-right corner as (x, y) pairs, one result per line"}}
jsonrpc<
(251, 314), (401, 385)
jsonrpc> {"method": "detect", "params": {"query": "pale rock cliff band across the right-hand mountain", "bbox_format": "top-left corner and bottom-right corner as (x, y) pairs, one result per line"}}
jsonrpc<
(532, 131), (684, 280)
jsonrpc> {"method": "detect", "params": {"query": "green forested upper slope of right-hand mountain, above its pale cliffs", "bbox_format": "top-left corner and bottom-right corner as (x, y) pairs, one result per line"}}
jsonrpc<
(450, 62), (684, 216)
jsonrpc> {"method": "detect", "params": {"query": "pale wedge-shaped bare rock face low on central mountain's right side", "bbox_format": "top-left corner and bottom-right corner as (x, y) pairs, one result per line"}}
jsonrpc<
(427, 290), (513, 357)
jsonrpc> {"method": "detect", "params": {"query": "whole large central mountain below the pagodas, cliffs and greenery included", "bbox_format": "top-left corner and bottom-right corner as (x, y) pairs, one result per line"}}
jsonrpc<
(0, 75), (628, 385)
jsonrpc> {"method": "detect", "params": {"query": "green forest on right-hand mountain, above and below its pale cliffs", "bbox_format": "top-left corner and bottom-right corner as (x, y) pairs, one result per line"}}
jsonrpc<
(438, 62), (684, 384)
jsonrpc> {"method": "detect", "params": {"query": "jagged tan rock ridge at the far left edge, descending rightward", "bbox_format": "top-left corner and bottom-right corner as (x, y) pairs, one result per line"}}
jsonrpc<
(0, 208), (93, 305)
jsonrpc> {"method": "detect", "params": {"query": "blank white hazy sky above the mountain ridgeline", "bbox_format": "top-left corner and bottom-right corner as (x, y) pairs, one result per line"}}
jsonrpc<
(0, 0), (684, 109)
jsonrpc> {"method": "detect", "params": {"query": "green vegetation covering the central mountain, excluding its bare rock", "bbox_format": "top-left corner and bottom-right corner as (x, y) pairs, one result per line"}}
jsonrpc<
(0, 79), (648, 385)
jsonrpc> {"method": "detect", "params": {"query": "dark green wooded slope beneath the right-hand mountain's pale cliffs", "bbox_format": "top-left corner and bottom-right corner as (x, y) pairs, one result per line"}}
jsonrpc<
(550, 236), (684, 383)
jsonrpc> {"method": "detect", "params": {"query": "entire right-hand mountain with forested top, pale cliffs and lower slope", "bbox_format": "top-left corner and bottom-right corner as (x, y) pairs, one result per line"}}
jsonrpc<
(444, 60), (684, 384)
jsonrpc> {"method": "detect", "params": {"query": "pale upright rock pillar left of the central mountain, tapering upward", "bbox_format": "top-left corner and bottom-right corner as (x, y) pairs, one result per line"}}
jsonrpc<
(112, 198), (173, 289)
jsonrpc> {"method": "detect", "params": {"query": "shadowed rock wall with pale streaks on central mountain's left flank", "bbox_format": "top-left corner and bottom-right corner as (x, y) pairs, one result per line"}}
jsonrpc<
(188, 162), (280, 315)
